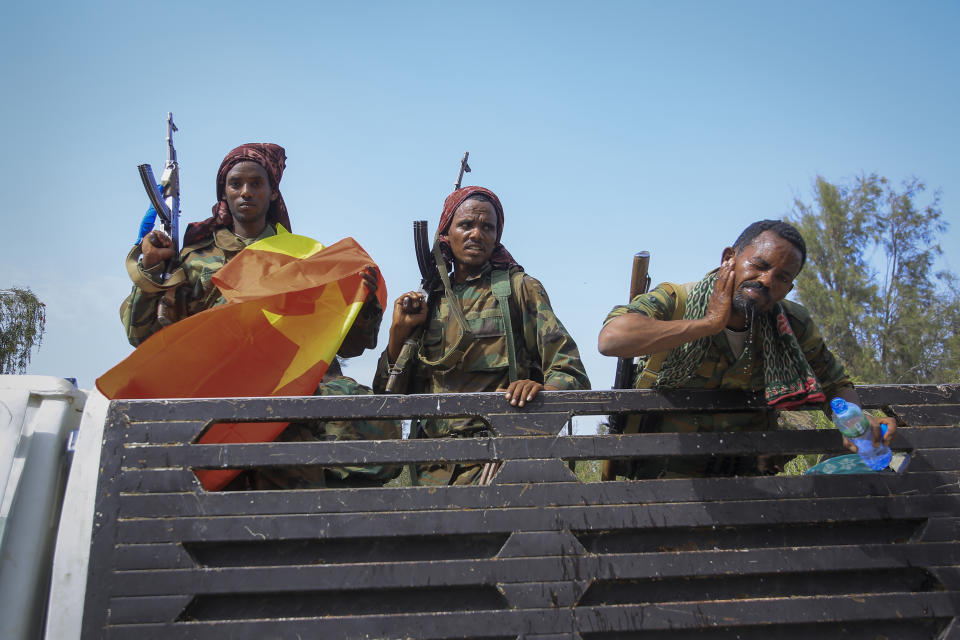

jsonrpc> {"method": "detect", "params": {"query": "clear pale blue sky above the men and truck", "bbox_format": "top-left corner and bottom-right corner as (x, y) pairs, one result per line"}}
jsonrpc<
(0, 1), (960, 416)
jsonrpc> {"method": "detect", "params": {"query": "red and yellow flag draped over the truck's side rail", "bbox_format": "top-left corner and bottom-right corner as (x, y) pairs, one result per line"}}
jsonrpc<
(97, 228), (386, 490)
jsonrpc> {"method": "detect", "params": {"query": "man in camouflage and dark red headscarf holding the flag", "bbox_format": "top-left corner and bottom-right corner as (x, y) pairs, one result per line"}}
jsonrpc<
(120, 144), (400, 489)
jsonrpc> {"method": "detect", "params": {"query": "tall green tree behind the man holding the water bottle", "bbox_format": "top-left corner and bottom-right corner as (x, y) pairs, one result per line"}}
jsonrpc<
(789, 174), (960, 383)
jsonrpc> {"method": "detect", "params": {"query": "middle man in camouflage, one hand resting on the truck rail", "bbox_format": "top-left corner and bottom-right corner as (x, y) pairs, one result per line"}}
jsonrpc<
(373, 187), (590, 484)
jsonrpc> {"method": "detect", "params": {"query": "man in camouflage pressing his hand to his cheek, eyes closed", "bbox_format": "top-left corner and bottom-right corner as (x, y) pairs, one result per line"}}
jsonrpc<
(599, 220), (895, 477)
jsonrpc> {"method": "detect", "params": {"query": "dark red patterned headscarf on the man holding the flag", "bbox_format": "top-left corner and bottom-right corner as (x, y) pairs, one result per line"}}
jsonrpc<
(183, 142), (290, 246)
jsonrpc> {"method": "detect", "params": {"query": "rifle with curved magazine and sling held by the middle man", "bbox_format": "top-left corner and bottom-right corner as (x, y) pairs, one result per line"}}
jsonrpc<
(386, 151), (473, 393)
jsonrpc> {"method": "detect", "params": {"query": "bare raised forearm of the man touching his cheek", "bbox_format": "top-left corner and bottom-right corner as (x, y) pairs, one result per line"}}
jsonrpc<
(598, 313), (722, 358)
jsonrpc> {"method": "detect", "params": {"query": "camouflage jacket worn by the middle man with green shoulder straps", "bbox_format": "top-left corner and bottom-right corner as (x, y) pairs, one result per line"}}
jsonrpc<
(373, 264), (590, 437)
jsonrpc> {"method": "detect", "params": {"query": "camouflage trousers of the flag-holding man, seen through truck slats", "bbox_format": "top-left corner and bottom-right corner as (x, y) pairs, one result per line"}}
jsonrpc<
(229, 370), (401, 490)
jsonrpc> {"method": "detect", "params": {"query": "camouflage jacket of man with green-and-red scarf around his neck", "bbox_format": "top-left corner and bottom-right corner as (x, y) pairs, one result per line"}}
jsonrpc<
(604, 285), (851, 431)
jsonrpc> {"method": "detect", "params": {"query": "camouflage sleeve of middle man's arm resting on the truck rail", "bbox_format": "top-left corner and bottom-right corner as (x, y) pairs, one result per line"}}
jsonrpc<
(514, 274), (590, 390)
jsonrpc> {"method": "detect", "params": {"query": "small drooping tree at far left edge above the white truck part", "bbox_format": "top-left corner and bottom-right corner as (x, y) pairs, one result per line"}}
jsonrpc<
(0, 287), (47, 373)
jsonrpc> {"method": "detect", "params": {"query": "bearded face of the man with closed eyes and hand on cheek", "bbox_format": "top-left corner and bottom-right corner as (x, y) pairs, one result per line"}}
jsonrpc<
(725, 231), (801, 317)
